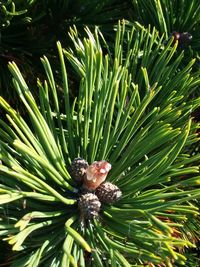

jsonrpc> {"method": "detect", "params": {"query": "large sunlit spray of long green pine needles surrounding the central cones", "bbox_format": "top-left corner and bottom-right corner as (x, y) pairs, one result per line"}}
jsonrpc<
(0, 23), (200, 267)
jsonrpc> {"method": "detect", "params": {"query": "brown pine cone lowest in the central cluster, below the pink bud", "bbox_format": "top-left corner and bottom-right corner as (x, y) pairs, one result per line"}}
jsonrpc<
(78, 193), (101, 219)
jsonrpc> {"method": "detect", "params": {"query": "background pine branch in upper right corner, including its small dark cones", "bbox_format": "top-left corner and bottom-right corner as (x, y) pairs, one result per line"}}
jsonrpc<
(129, 0), (200, 72)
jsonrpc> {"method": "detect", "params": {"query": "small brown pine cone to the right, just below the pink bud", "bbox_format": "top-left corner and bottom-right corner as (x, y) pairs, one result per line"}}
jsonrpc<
(95, 182), (122, 204)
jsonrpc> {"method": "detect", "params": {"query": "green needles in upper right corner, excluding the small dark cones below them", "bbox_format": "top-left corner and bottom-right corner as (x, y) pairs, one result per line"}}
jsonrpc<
(131, 0), (200, 44)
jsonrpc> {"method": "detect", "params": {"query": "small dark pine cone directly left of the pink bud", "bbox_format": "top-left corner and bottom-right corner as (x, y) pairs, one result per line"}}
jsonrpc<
(70, 158), (88, 182)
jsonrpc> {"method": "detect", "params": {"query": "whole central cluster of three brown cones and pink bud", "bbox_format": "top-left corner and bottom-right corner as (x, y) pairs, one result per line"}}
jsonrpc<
(71, 158), (122, 219)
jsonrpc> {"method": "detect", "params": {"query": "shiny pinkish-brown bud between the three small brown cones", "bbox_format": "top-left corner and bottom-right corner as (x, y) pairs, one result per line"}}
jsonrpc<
(83, 160), (111, 190)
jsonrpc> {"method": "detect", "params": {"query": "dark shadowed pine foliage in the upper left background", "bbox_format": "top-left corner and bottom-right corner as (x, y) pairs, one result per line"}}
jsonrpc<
(0, 0), (127, 104)
